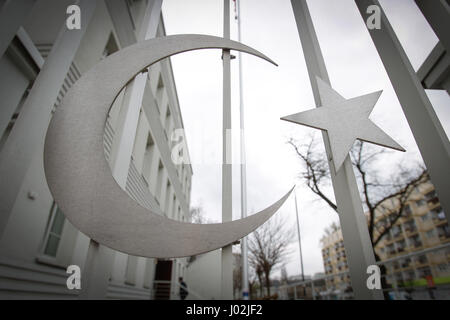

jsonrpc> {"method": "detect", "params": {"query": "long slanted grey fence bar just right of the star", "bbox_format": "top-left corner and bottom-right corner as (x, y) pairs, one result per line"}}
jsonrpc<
(355, 0), (450, 225)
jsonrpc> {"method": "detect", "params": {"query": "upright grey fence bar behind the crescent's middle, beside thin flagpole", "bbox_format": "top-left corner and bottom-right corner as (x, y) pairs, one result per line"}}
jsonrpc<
(222, 0), (233, 300)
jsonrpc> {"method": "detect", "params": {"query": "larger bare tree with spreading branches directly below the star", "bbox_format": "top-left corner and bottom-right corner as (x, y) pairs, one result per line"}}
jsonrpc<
(288, 137), (429, 252)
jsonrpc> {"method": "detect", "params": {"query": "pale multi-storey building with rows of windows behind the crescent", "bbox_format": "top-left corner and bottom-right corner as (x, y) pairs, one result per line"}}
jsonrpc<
(0, 0), (192, 299)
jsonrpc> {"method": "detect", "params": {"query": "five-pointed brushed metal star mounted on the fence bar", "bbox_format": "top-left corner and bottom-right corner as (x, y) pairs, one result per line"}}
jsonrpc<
(281, 77), (405, 171)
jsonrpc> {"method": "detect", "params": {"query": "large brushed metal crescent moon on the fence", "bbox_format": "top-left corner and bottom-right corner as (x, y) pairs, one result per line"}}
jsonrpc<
(44, 35), (292, 258)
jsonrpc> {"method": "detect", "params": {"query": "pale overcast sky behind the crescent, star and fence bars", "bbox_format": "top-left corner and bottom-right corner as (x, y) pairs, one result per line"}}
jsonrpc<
(163, 0), (450, 275)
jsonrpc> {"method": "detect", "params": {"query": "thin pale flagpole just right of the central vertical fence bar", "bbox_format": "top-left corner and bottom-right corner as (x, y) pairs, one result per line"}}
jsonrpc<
(236, 0), (249, 300)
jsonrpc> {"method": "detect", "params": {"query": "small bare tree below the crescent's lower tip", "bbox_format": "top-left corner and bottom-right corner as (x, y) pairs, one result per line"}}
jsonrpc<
(248, 216), (294, 296)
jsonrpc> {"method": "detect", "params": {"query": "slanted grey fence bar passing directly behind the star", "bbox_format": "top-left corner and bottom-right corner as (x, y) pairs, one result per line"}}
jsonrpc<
(291, 0), (383, 300)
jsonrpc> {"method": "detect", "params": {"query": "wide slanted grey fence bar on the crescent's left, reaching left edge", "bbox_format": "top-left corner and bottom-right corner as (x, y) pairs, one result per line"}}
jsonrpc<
(0, 0), (100, 236)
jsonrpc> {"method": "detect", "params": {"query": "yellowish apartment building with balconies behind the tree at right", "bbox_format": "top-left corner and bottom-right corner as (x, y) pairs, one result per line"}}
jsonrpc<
(322, 182), (450, 298)
